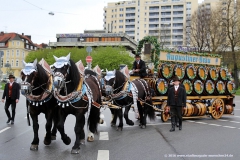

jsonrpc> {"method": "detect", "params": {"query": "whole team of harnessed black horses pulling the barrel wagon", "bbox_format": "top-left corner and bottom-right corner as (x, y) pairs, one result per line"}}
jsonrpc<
(21, 54), (155, 154)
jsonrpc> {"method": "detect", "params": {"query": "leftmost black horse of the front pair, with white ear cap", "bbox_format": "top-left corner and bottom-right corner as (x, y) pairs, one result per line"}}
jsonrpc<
(21, 60), (57, 150)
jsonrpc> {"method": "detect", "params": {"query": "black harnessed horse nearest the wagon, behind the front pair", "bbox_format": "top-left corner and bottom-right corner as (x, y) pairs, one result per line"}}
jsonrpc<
(105, 70), (155, 130)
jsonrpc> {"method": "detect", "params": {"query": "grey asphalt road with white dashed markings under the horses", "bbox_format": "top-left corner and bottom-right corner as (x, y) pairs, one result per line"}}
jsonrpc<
(0, 93), (240, 160)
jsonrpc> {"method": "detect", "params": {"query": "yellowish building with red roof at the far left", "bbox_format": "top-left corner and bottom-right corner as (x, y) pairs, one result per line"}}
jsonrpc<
(0, 32), (38, 77)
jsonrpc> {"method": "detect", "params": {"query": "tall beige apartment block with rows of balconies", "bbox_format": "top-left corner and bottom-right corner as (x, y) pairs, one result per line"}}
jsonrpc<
(103, 0), (198, 48)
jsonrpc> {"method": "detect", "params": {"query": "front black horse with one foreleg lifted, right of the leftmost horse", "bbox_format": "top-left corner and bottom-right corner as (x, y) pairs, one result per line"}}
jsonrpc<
(53, 55), (101, 154)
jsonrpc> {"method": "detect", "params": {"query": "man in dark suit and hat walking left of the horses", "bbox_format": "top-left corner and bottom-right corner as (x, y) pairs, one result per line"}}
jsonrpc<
(2, 75), (20, 124)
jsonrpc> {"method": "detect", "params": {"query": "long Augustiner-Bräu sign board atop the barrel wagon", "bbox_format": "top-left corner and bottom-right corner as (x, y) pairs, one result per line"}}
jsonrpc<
(160, 52), (221, 66)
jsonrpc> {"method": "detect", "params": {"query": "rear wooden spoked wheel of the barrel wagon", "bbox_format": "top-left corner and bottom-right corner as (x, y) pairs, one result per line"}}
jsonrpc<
(211, 98), (224, 119)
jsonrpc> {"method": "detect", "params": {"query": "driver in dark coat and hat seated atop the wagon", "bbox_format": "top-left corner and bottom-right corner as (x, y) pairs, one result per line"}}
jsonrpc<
(133, 54), (147, 78)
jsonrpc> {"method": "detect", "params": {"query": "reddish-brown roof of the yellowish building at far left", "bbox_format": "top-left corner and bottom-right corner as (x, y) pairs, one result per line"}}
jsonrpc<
(0, 32), (36, 46)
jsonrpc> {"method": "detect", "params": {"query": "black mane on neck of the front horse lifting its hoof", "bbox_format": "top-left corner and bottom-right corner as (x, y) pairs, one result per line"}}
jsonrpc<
(68, 59), (80, 92)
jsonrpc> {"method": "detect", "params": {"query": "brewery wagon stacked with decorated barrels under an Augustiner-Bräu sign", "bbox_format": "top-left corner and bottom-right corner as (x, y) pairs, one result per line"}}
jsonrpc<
(141, 52), (235, 122)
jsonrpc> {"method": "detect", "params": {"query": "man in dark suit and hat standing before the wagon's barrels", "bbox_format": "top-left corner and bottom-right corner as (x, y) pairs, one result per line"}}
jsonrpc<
(167, 76), (187, 132)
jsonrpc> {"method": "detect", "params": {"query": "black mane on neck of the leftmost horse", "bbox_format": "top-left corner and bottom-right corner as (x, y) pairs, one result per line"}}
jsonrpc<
(33, 64), (49, 95)
